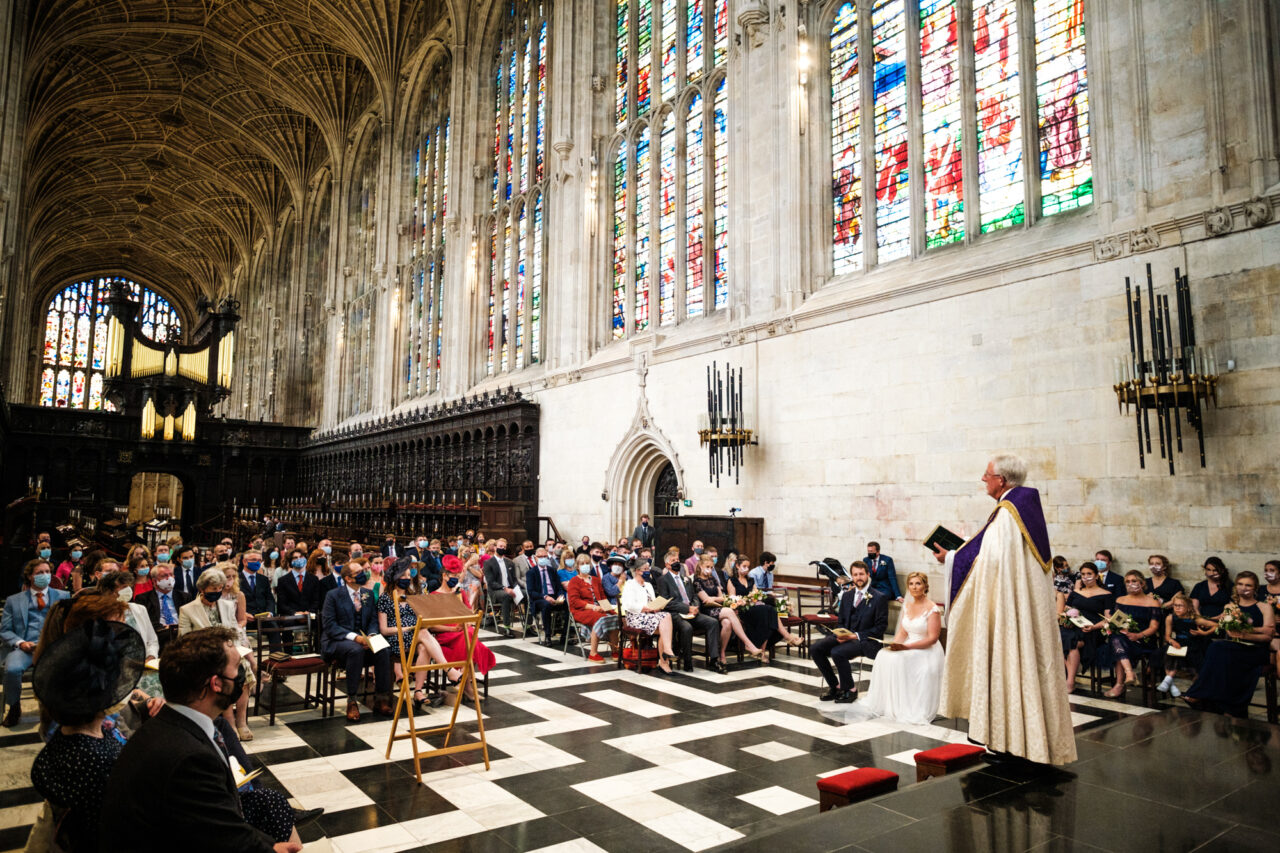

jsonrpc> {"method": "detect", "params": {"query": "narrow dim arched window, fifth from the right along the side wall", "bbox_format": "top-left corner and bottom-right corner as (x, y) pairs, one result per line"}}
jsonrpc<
(338, 123), (383, 418)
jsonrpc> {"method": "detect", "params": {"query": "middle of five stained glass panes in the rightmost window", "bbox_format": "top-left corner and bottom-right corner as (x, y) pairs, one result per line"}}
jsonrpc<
(920, 0), (964, 248)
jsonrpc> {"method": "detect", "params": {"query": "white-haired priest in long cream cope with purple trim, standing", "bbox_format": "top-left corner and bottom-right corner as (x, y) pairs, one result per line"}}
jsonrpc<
(936, 455), (1075, 765)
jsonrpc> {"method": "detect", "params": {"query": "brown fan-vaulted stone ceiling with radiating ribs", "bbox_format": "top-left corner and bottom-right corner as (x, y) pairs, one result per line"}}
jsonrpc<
(24, 0), (449, 301)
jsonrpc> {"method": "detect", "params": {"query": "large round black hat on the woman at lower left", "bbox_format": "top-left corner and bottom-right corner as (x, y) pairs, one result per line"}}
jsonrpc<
(31, 620), (147, 722)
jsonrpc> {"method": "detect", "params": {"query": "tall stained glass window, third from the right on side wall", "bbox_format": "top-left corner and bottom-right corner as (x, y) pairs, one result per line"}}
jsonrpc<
(485, 0), (550, 374)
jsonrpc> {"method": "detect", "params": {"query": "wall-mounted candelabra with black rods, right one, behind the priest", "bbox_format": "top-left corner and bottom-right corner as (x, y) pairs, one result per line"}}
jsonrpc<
(1112, 264), (1217, 474)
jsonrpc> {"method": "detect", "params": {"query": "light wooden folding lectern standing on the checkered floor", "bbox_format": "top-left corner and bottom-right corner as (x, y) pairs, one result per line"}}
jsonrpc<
(387, 589), (489, 785)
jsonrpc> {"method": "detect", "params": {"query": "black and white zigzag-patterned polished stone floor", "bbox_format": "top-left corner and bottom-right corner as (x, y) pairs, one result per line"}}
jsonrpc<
(0, 635), (1167, 853)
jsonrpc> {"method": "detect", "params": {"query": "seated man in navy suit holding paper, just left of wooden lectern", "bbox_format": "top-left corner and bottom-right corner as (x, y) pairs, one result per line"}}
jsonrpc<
(320, 564), (392, 722)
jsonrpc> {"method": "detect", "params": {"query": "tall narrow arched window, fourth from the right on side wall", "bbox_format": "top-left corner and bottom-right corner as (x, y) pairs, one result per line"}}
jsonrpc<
(403, 69), (449, 397)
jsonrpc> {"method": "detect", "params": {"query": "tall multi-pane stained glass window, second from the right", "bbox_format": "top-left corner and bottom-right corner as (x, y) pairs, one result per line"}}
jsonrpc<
(609, 0), (730, 338)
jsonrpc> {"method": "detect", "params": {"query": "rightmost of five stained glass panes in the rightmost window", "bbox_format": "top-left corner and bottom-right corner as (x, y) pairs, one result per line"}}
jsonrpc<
(1036, 0), (1093, 216)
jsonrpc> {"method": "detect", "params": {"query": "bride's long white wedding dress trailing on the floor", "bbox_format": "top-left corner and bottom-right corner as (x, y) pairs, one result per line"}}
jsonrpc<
(819, 596), (946, 725)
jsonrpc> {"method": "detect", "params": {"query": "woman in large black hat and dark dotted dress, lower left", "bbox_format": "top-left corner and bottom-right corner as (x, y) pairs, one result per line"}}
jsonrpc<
(31, 620), (145, 852)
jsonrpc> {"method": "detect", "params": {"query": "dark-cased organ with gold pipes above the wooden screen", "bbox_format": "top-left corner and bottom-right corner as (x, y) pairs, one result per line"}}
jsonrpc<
(105, 282), (239, 442)
